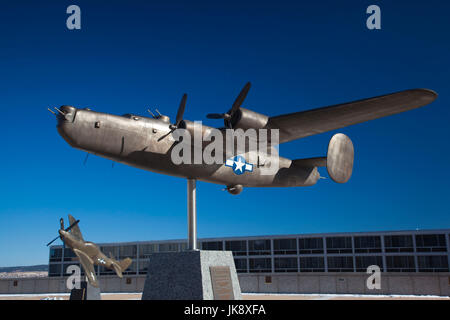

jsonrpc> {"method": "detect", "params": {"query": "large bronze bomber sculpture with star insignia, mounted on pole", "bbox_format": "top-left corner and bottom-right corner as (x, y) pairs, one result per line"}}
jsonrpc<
(49, 83), (437, 194)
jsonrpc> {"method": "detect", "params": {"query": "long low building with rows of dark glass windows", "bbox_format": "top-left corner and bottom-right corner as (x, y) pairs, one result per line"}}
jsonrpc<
(49, 229), (450, 278)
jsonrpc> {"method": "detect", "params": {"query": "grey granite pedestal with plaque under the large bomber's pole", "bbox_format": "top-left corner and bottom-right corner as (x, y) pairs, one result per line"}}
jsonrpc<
(142, 250), (242, 300)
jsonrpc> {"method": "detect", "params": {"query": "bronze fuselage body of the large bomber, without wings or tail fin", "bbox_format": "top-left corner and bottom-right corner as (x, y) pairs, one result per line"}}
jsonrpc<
(57, 106), (320, 187)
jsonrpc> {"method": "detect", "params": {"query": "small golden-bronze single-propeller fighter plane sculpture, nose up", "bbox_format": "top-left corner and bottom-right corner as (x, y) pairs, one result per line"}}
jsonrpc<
(47, 214), (132, 288)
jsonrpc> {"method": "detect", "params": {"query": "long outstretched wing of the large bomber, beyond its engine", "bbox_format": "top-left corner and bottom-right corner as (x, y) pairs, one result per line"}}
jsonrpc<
(266, 89), (437, 143)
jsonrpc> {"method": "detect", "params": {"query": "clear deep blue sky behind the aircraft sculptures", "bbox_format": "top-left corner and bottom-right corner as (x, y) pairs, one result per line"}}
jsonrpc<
(0, 0), (450, 266)
